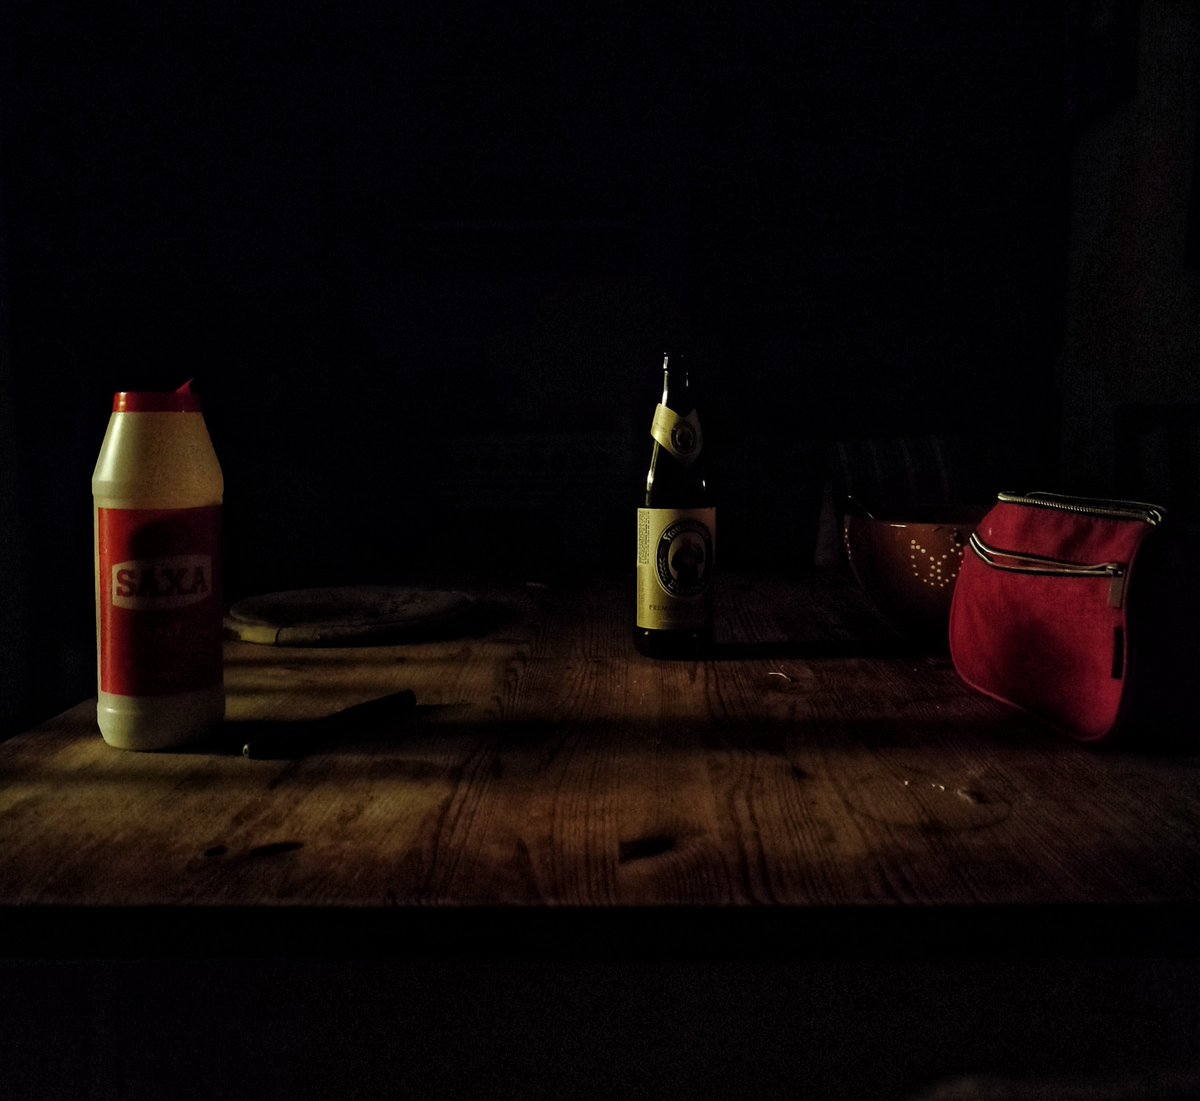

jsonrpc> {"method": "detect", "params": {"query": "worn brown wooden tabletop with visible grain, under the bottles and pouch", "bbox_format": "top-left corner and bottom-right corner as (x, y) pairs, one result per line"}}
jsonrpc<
(0, 577), (1200, 954)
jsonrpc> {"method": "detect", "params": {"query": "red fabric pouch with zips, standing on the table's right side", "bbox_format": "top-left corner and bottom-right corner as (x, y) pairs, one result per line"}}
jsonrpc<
(949, 493), (1194, 741)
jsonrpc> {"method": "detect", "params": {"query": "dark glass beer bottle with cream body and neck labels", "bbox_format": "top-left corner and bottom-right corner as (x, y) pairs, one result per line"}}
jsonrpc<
(634, 355), (716, 657)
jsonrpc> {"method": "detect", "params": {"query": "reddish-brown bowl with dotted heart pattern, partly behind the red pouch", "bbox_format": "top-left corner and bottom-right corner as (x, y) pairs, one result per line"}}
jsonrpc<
(842, 505), (988, 642)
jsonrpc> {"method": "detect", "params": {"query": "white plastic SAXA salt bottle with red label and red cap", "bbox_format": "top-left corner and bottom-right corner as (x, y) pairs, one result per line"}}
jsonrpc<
(91, 381), (224, 750)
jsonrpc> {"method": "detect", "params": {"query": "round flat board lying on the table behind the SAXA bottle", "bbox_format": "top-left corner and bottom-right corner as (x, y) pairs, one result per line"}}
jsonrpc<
(224, 585), (476, 646)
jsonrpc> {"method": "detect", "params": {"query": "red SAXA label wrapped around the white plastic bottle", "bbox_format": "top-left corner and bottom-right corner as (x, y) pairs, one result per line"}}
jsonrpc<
(96, 505), (223, 696)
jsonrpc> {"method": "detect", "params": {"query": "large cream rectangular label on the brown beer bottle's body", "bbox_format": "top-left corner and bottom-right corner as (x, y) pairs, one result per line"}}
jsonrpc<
(637, 509), (716, 631)
